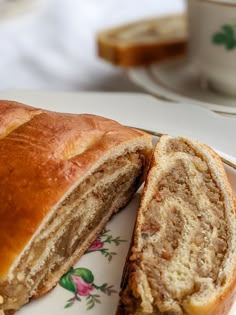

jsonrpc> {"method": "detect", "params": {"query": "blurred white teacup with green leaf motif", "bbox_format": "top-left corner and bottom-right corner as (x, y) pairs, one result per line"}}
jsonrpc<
(188, 0), (236, 96)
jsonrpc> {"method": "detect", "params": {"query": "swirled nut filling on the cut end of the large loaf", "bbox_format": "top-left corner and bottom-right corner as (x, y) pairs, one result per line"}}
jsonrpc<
(0, 151), (145, 310)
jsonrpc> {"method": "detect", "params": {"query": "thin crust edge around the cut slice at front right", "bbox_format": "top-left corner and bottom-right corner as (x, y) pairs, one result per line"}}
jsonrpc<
(116, 136), (236, 315)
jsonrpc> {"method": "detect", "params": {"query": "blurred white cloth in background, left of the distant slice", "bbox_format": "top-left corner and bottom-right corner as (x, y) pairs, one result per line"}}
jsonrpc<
(0, 0), (185, 91)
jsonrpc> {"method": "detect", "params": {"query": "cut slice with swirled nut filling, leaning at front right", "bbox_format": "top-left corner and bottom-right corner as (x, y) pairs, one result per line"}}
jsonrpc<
(118, 136), (236, 315)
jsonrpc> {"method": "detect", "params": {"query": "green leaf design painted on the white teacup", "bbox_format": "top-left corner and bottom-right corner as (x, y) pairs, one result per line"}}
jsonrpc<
(212, 24), (236, 50)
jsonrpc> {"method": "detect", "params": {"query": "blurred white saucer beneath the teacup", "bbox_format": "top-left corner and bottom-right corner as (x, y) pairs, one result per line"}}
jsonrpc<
(127, 58), (236, 114)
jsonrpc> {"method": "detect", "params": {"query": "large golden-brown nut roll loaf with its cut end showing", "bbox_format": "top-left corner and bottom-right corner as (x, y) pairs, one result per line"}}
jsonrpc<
(0, 101), (152, 310)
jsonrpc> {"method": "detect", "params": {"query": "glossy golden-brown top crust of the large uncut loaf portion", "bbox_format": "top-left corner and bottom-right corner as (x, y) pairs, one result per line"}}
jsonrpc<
(0, 101), (151, 278)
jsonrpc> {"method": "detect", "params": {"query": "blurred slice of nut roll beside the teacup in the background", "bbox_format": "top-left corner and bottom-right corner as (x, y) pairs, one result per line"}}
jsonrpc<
(97, 15), (187, 67)
